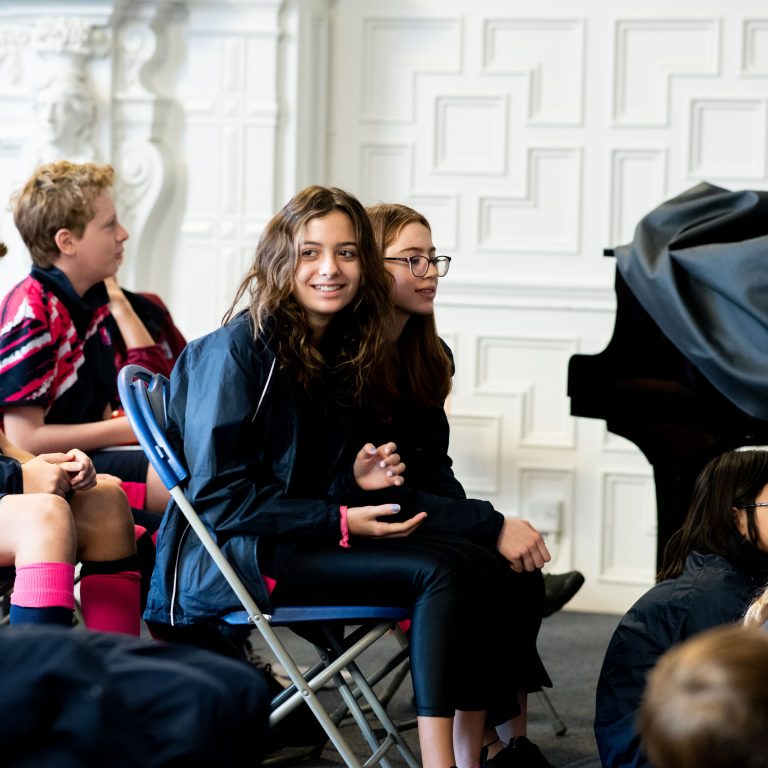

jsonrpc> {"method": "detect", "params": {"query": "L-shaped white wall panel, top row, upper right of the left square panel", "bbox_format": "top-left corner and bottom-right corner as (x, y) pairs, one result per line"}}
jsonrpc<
(482, 19), (585, 126)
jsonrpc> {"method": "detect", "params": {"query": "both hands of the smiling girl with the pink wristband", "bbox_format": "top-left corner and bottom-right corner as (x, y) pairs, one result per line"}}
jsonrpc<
(347, 443), (427, 538)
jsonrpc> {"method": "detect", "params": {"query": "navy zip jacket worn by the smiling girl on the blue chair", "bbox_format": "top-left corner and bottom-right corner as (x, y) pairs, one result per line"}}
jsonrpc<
(144, 313), (360, 626)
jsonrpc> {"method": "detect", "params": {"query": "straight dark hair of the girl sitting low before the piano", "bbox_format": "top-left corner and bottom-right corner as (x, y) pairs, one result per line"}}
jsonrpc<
(657, 450), (768, 581)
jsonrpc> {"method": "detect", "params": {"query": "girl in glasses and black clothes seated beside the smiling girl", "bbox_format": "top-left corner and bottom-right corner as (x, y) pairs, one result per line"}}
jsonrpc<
(368, 204), (550, 768)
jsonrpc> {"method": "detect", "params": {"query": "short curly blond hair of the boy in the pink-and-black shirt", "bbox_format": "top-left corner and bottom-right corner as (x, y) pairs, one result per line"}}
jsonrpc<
(12, 160), (115, 269)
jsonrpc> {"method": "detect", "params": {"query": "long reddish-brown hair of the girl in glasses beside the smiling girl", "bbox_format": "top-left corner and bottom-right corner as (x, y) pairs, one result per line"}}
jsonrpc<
(368, 203), (453, 408)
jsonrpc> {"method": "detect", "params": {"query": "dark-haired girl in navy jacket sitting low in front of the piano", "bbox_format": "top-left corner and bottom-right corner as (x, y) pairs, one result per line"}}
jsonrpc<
(595, 450), (768, 768)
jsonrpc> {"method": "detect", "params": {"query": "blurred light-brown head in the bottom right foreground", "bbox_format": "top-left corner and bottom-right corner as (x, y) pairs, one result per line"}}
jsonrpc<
(638, 626), (768, 768)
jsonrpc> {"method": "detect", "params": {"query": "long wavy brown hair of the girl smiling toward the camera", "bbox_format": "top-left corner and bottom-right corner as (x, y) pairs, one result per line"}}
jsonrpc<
(224, 186), (395, 403)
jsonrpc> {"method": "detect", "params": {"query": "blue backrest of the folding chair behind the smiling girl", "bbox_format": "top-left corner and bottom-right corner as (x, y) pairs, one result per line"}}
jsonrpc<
(117, 365), (189, 490)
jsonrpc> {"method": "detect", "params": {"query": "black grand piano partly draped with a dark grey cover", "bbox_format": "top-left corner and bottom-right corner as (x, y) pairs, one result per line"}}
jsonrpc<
(568, 184), (768, 564)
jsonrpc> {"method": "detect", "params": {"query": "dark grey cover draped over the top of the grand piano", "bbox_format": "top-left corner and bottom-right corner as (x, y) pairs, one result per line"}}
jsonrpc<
(615, 183), (768, 420)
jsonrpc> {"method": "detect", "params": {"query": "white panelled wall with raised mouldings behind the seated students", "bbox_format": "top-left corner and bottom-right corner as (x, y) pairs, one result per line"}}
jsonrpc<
(0, 0), (768, 611)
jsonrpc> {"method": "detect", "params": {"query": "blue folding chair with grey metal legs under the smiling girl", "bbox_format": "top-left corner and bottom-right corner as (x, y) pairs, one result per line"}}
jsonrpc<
(118, 365), (419, 768)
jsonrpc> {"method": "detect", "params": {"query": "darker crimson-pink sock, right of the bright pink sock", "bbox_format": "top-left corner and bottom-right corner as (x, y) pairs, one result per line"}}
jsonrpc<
(80, 571), (141, 637)
